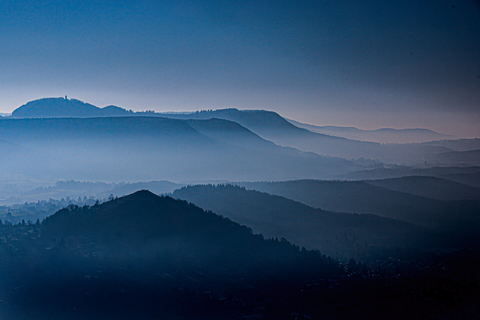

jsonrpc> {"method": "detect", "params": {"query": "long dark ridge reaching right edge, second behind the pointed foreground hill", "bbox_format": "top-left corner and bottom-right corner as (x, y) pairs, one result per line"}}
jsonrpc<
(238, 180), (480, 229)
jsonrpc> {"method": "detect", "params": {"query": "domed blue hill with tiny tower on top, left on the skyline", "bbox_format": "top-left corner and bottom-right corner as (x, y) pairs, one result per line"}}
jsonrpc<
(12, 97), (133, 118)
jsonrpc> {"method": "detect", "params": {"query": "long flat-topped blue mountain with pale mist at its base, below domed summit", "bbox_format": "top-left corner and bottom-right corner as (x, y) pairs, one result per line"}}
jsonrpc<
(0, 117), (354, 181)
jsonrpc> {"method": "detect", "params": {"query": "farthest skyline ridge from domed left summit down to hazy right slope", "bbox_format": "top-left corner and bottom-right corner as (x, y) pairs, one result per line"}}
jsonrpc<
(12, 98), (464, 164)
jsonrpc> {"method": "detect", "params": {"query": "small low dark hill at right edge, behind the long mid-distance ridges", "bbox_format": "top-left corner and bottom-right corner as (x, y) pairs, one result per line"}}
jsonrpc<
(365, 176), (480, 200)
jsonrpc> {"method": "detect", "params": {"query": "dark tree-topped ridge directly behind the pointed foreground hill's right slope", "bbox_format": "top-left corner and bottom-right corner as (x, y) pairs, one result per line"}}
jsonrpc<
(173, 185), (432, 260)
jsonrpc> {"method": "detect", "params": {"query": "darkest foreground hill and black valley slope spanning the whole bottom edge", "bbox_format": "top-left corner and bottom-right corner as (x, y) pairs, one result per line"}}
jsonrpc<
(0, 191), (480, 320)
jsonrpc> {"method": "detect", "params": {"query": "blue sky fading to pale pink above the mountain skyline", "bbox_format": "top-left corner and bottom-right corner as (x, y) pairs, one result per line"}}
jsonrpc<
(0, 0), (480, 137)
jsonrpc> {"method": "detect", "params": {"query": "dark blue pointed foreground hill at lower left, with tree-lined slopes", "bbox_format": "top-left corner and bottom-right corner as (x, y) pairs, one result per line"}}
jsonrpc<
(0, 191), (339, 319)
